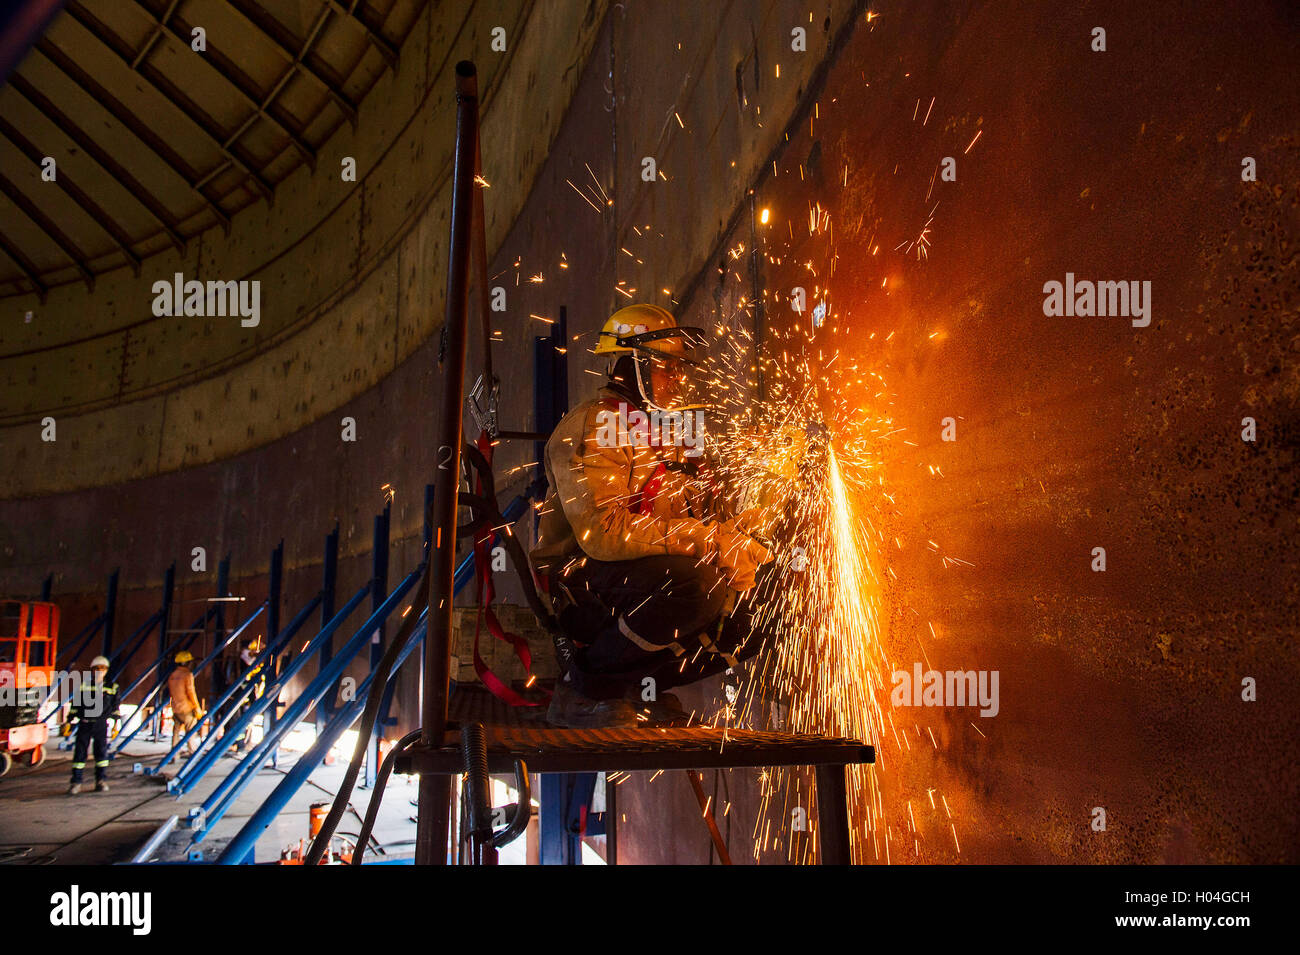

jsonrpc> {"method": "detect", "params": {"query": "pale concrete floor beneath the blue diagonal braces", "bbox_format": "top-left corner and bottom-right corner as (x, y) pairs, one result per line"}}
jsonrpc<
(0, 742), (416, 865)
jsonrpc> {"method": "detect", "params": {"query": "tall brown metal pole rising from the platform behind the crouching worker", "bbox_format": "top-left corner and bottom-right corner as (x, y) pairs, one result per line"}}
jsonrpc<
(415, 60), (478, 865)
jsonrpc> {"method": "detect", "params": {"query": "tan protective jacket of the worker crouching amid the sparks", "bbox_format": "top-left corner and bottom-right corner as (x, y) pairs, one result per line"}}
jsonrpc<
(529, 388), (718, 579)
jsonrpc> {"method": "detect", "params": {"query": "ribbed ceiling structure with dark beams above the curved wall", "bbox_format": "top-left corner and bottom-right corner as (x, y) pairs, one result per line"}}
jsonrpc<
(0, 0), (428, 298)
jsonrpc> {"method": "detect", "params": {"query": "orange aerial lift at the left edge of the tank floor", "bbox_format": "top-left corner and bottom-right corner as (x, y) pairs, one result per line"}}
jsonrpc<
(0, 600), (59, 776)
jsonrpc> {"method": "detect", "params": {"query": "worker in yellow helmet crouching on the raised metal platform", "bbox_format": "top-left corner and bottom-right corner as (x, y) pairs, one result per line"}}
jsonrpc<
(530, 305), (770, 728)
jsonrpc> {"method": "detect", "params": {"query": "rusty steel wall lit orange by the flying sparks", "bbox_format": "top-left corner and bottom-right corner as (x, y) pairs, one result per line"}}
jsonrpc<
(620, 1), (1300, 863)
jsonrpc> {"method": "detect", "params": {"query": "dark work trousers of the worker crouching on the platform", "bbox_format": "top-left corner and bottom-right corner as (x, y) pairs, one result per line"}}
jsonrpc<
(553, 556), (763, 699)
